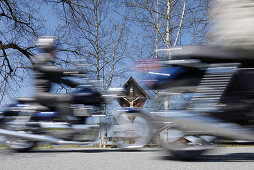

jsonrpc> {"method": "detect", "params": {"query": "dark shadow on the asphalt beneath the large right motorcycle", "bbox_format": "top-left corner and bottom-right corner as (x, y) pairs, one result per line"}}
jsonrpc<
(160, 153), (254, 162)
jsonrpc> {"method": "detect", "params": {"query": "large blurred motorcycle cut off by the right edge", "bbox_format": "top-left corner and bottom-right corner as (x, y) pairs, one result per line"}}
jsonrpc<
(143, 47), (254, 159)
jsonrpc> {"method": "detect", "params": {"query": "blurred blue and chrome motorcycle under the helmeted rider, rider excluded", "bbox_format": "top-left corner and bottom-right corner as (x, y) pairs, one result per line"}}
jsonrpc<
(0, 64), (150, 152)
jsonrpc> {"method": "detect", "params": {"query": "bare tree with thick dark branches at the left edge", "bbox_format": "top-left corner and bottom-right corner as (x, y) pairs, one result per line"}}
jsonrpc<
(0, 0), (46, 102)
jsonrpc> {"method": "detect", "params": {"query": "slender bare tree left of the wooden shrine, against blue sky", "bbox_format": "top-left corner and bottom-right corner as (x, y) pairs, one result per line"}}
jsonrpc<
(45, 0), (128, 146)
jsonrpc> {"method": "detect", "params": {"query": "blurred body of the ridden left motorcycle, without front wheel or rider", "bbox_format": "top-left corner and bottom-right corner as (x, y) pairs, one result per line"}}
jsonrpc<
(0, 69), (105, 151)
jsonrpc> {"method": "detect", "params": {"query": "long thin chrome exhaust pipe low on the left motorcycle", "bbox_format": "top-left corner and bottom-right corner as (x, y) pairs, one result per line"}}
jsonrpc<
(0, 129), (91, 145)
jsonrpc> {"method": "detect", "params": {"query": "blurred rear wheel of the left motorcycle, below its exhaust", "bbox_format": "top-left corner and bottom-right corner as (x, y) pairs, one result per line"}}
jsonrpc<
(6, 137), (36, 152)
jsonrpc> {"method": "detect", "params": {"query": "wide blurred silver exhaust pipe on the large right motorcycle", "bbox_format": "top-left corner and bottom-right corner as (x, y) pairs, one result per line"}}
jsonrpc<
(153, 111), (254, 141)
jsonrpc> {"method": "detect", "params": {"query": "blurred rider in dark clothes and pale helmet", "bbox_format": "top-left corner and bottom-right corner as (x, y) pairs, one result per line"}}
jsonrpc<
(33, 36), (78, 122)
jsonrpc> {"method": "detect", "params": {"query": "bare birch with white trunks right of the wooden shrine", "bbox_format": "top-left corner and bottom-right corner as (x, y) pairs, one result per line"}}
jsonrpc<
(125, 0), (209, 141)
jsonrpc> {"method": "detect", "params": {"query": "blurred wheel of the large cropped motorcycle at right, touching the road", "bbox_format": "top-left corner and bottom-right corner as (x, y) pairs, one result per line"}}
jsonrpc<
(162, 136), (214, 160)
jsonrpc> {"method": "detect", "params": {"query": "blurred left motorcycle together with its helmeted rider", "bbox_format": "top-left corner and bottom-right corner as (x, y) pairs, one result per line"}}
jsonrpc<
(0, 36), (149, 151)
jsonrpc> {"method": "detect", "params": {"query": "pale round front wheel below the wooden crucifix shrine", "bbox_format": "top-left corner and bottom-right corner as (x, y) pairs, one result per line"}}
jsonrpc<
(113, 113), (152, 149)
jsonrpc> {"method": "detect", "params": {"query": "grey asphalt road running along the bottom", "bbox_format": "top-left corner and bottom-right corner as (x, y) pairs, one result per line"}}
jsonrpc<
(0, 147), (254, 170)
